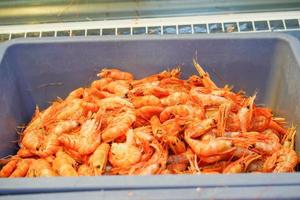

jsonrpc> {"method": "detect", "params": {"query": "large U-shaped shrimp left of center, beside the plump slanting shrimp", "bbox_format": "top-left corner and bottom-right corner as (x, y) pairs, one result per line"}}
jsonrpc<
(58, 119), (101, 155)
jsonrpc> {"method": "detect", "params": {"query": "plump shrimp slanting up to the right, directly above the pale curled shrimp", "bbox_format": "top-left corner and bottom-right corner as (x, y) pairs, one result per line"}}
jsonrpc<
(101, 109), (136, 142)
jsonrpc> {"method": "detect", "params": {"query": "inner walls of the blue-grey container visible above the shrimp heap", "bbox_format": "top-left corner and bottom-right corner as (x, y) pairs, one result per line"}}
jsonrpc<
(0, 37), (300, 156)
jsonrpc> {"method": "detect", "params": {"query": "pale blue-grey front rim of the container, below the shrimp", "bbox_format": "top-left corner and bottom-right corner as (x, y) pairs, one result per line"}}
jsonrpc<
(0, 172), (300, 194)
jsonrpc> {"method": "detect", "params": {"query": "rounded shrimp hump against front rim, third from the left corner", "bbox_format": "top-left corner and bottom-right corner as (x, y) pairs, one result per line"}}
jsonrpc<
(26, 159), (57, 177)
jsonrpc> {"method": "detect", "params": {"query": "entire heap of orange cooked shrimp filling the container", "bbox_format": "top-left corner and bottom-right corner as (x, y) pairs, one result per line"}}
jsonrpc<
(0, 60), (298, 177)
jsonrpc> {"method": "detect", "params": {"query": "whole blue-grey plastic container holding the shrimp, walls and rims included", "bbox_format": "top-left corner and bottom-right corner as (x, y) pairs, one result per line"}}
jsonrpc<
(0, 34), (300, 199)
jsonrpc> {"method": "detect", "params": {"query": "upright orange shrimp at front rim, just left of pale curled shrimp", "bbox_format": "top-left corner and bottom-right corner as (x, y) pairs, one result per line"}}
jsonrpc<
(88, 143), (110, 176)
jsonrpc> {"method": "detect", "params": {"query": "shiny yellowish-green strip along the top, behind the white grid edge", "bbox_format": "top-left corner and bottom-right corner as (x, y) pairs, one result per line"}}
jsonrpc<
(0, 0), (300, 25)
